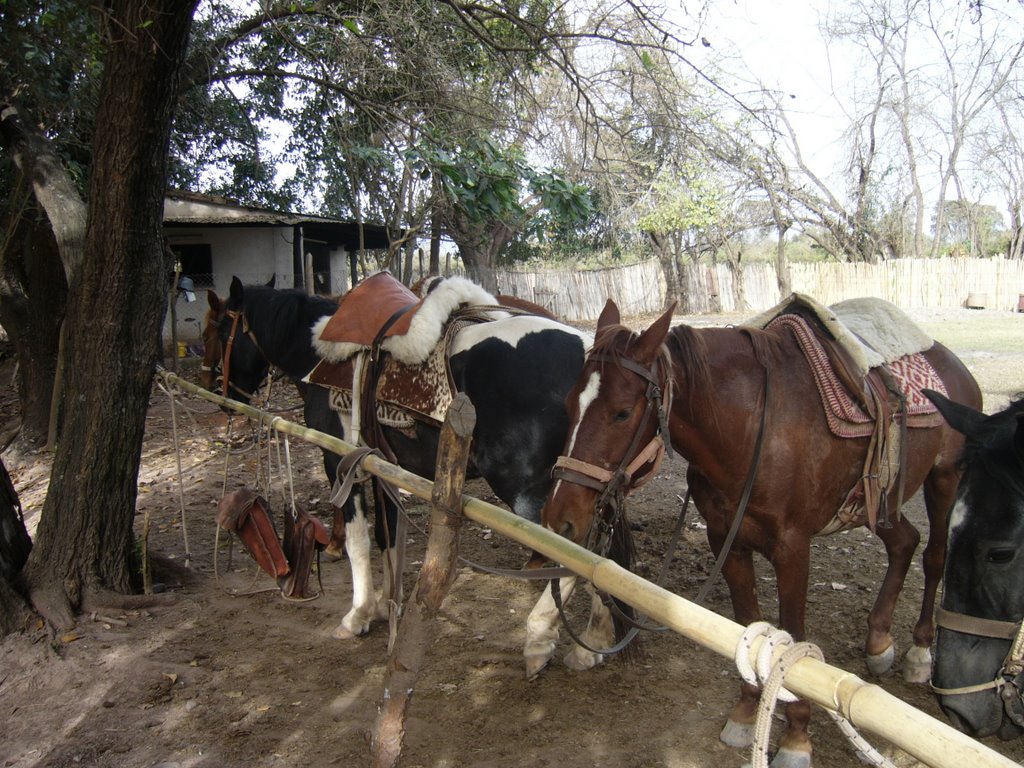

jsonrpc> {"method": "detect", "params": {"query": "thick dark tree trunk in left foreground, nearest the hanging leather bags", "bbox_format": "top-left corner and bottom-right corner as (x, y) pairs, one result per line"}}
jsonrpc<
(25, 0), (195, 628)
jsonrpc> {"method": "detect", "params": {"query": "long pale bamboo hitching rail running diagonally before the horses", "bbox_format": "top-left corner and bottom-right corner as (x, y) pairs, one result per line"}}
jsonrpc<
(159, 371), (1018, 768)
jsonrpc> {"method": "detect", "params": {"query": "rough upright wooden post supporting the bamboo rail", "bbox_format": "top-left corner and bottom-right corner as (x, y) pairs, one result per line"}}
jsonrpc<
(370, 393), (476, 768)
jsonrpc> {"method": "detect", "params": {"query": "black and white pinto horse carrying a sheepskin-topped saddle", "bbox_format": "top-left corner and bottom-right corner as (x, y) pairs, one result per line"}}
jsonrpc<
(206, 278), (615, 677)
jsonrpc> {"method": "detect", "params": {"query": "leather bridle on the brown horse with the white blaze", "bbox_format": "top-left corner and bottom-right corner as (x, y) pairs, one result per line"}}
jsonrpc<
(551, 353), (672, 554)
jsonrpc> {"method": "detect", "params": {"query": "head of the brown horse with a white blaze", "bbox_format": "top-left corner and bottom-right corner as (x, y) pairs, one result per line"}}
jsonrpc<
(541, 300), (673, 548)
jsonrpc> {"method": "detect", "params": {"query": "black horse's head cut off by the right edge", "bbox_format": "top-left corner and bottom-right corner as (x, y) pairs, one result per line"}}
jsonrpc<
(926, 391), (1024, 739)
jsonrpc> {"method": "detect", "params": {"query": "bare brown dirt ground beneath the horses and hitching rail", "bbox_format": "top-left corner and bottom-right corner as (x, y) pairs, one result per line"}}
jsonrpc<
(0, 310), (1024, 768)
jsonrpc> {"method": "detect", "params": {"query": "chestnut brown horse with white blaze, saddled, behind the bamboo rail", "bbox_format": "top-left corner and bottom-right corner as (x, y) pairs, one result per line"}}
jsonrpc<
(542, 300), (981, 768)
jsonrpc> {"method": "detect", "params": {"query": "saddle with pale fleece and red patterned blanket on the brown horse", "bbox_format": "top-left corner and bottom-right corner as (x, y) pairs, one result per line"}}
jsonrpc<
(748, 294), (945, 535)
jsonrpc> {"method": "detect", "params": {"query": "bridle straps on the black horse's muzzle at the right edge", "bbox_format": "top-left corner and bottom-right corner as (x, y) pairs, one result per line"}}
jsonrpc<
(932, 606), (1024, 728)
